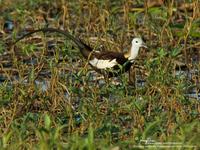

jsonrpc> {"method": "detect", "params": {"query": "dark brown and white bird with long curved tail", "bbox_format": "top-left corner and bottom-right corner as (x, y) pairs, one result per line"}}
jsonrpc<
(14, 28), (147, 77)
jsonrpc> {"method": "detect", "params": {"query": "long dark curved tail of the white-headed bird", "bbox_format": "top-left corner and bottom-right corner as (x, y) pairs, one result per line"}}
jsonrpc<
(13, 28), (92, 59)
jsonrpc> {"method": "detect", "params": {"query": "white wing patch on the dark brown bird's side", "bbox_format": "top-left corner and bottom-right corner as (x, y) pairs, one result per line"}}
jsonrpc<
(89, 58), (118, 69)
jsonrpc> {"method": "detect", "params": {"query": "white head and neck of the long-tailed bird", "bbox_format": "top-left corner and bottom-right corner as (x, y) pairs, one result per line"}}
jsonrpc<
(128, 38), (147, 61)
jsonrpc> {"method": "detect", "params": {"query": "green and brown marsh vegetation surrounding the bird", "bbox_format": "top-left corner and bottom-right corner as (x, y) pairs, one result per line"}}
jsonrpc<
(0, 0), (200, 150)
